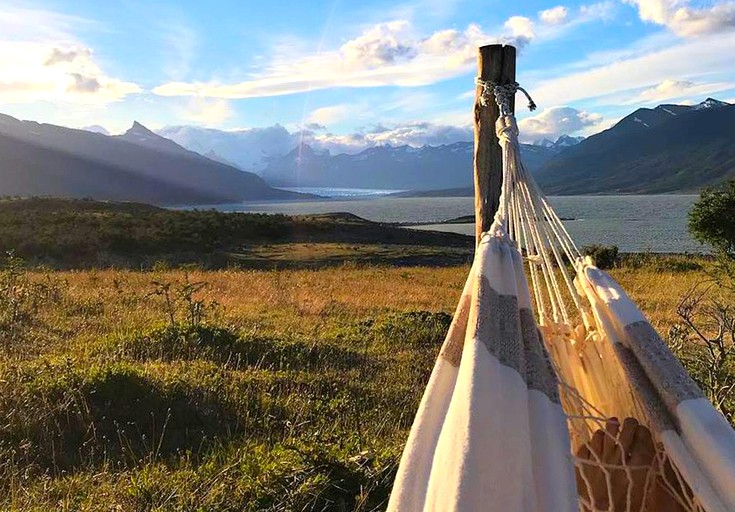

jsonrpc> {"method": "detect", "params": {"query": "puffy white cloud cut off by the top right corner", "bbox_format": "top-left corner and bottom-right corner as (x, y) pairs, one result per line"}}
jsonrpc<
(623, 0), (735, 37)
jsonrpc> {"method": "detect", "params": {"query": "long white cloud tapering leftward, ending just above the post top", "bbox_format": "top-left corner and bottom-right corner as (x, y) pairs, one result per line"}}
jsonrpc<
(153, 17), (533, 99)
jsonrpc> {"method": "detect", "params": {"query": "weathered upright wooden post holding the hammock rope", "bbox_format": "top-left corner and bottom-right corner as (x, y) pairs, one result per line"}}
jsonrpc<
(474, 44), (516, 243)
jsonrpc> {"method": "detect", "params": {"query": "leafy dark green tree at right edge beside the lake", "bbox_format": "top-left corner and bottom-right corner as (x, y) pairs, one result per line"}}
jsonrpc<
(689, 180), (735, 260)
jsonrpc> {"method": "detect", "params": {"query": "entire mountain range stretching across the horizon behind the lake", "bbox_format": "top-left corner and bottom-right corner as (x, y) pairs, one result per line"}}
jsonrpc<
(0, 98), (735, 205)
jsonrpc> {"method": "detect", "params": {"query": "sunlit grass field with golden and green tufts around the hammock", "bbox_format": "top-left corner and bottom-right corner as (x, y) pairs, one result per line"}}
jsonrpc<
(0, 254), (724, 511)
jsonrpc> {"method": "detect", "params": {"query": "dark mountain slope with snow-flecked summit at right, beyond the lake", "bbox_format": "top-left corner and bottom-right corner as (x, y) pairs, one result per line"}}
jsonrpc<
(536, 98), (735, 194)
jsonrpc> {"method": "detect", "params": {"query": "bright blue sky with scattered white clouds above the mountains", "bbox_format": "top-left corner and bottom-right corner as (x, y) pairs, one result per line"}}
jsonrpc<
(0, 0), (735, 152)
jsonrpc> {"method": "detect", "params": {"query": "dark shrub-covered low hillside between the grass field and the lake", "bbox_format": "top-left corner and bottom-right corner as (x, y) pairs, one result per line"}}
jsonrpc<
(0, 199), (474, 268)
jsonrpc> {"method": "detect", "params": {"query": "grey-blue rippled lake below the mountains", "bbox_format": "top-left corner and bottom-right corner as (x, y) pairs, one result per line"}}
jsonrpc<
(188, 193), (707, 253)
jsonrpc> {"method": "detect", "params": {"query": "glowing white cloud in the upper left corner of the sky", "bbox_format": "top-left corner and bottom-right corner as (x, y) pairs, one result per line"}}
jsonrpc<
(0, 6), (141, 104)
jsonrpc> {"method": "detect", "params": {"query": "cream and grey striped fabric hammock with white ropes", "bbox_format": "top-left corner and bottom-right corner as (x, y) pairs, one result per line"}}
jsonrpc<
(388, 83), (735, 512)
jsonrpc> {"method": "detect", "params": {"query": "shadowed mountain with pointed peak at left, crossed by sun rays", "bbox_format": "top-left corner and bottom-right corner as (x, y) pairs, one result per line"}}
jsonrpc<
(0, 114), (300, 204)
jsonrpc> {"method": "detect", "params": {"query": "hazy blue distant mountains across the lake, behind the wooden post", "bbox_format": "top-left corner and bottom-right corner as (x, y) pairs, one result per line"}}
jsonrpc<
(261, 142), (572, 190)
